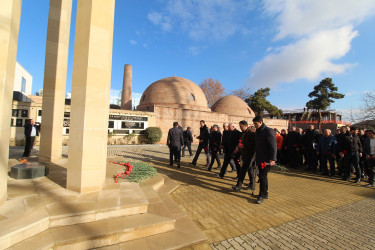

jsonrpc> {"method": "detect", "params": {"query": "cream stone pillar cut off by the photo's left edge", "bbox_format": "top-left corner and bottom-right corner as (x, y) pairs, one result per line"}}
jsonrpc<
(0, 0), (22, 204)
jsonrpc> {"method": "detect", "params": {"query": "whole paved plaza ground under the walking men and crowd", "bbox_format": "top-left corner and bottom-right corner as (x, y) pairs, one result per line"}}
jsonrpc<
(11, 145), (375, 249)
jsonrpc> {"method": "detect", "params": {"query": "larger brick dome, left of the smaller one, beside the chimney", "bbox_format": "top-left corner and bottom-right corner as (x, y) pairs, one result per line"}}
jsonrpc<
(137, 76), (210, 111)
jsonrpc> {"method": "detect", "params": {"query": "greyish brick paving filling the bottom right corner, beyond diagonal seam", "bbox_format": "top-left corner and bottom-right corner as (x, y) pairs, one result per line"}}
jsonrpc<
(211, 199), (375, 249)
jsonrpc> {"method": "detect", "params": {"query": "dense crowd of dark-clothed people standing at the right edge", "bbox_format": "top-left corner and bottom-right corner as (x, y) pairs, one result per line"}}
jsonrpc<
(276, 125), (375, 187)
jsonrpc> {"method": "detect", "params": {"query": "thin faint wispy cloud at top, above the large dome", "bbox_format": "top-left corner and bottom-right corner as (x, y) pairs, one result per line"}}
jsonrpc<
(148, 0), (254, 41)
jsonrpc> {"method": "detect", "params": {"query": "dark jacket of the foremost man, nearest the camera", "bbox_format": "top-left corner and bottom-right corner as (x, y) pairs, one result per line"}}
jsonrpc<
(255, 123), (277, 164)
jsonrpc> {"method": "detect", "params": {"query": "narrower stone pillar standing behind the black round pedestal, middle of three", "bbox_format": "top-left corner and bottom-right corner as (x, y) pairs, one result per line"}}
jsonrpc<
(39, 0), (72, 162)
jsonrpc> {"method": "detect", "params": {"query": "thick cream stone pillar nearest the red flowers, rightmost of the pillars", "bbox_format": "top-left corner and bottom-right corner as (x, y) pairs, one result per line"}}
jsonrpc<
(67, 0), (115, 193)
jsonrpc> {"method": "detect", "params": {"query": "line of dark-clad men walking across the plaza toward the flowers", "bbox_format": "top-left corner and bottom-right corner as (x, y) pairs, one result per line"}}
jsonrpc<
(167, 116), (277, 204)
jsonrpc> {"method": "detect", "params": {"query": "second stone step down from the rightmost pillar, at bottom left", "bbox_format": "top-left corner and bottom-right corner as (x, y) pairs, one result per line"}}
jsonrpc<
(10, 214), (175, 250)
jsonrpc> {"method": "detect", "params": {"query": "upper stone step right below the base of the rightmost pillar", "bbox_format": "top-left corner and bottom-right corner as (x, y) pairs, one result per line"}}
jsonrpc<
(46, 183), (149, 228)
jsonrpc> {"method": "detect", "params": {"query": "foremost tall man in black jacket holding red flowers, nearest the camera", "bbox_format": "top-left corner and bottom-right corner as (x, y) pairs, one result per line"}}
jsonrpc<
(253, 116), (277, 204)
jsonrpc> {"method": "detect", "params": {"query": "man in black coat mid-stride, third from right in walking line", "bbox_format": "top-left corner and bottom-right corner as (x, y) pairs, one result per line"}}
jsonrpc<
(219, 123), (241, 178)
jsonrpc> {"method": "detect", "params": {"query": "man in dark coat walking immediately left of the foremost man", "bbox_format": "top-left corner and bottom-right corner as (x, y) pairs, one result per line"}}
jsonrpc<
(232, 121), (256, 191)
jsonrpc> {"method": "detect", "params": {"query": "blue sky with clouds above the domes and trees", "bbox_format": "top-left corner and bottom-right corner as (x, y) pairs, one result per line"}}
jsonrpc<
(17, 0), (375, 120)
